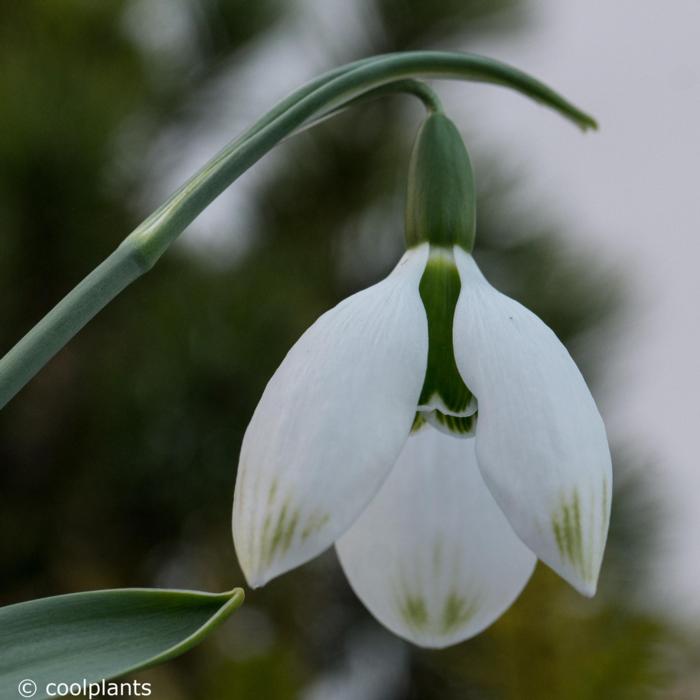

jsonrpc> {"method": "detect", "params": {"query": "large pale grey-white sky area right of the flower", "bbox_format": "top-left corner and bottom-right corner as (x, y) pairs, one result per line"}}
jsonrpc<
(460, 0), (700, 617)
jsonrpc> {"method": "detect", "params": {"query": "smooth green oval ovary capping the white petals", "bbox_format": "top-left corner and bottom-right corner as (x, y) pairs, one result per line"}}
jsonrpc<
(406, 112), (476, 252)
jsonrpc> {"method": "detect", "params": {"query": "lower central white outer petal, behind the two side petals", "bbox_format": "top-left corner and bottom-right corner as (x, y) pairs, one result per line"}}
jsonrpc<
(336, 426), (536, 648)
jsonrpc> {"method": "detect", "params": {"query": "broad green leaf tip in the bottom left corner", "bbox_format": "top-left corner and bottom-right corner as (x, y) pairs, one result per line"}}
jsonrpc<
(0, 588), (243, 698)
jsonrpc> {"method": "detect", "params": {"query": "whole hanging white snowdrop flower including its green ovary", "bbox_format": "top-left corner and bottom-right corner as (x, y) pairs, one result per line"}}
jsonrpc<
(233, 114), (612, 647)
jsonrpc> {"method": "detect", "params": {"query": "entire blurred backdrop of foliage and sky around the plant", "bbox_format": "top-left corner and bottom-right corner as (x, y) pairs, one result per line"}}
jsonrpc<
(0, 0), (700, 700)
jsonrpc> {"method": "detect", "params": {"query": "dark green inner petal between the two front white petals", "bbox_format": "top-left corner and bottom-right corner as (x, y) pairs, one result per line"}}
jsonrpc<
(418, 246), (475, 416)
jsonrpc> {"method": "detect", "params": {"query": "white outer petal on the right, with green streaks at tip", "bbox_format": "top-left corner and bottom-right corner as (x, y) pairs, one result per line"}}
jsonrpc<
(454, 248), (612, 596)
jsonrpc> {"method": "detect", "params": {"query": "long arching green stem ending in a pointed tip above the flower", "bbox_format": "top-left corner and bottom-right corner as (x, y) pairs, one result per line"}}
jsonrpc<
(0, 51), (595, 408)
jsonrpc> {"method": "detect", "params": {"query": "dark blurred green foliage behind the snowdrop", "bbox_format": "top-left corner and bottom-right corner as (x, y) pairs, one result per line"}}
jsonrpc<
(0, 0), (700, 700)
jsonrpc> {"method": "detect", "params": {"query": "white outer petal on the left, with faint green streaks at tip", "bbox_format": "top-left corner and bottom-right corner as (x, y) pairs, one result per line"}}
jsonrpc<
(233, 245), (428, 587)
